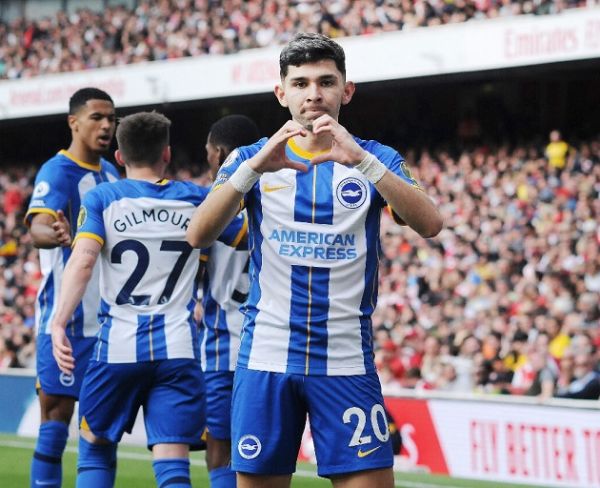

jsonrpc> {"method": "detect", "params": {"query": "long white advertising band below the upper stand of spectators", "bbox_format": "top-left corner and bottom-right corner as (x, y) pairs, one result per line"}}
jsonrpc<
(0, 7), (600, 120)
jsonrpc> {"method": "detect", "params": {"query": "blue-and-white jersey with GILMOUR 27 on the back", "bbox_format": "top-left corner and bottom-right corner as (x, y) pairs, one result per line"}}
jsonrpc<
(75, 179), (241, 363)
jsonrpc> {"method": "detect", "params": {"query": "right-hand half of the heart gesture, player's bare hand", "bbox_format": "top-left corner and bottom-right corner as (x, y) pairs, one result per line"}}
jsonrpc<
(310, 114), (367, 166)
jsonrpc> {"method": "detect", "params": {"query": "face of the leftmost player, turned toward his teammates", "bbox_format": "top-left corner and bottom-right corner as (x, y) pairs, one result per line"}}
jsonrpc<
(69, 100), (116, 154)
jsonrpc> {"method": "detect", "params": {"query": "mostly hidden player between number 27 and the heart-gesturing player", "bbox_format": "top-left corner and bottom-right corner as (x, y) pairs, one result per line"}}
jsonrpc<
(201, 115), (259, 488)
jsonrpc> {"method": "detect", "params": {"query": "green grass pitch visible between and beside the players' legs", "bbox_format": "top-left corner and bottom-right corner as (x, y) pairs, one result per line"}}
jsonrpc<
(0, 434), (526, 488)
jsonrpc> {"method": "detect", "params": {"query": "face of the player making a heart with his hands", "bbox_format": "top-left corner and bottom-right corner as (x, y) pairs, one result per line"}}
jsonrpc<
(275, 59), (354, 127)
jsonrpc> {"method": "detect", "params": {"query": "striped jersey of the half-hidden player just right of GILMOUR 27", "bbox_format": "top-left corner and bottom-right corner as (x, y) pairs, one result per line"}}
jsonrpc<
(200, 212), (249, 371)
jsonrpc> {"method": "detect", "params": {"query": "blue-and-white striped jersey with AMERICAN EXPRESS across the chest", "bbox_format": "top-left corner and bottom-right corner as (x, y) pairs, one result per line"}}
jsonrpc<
(213, 138), (418, 375)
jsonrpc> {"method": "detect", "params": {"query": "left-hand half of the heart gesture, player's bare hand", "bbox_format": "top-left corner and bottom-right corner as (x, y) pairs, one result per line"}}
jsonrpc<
(248, 120), (308, 173)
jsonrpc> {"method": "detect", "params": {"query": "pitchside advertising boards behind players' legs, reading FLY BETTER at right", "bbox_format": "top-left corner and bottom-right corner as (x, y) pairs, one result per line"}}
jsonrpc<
(0, 369), (600, 488)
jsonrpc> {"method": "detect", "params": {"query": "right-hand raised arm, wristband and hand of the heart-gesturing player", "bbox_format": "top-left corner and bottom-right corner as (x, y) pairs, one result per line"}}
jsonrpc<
(311, 115), (443, 237)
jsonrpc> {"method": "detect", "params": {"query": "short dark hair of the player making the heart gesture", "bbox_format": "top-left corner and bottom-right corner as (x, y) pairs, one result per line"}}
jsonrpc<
(279, 32), (346, 79)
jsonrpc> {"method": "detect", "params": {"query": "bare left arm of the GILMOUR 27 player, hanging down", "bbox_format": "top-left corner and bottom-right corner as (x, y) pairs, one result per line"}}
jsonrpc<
(50, 237), (102, 373)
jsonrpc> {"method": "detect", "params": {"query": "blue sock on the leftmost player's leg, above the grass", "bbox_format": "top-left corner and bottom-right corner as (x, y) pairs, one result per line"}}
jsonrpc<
(30, 420), (69, 488)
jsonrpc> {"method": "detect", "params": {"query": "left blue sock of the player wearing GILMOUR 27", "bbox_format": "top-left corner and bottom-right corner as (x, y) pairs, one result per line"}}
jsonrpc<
(76, 436), (117, 488)
